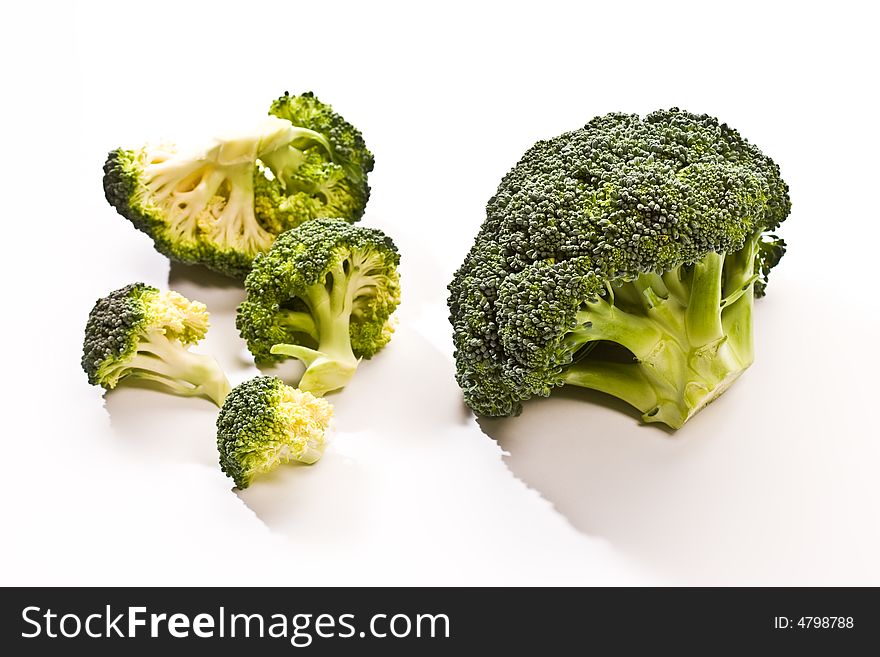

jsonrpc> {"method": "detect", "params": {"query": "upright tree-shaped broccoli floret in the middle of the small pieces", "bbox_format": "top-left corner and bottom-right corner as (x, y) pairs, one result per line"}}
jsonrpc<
(236, 219), (400, 396)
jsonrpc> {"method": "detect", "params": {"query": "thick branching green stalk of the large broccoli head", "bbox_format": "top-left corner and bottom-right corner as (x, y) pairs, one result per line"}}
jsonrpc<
(564, 240), (757, 429)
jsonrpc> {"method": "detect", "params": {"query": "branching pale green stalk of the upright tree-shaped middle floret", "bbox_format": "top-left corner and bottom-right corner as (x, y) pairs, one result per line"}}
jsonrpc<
(270, 251), (387, 396)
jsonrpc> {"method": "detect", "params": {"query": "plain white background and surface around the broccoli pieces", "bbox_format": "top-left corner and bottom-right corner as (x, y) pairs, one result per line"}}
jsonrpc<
(0, 1), (880, 585)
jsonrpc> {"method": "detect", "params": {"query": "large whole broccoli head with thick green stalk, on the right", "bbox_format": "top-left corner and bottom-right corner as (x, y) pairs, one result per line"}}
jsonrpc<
(449, 108), (791, 429)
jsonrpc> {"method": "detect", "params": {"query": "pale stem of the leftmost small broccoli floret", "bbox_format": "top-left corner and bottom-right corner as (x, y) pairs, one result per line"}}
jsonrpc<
(126, 331), (230, 406)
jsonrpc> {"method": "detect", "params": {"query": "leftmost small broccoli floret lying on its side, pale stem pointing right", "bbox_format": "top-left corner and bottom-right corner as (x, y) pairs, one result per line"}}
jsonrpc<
(82, 283), (229, 406)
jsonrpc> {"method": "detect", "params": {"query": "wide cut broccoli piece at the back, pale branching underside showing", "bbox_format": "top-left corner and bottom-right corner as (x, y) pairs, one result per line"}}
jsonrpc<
(104, 93), (373, 278)
